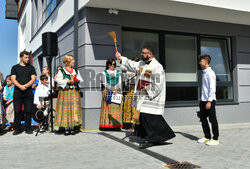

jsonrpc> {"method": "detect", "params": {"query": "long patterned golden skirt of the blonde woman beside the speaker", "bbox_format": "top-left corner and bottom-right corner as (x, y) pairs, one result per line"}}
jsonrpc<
(55, 89), (82, 127)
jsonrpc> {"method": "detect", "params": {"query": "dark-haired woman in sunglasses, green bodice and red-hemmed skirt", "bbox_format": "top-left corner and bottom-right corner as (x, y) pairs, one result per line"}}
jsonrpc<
(99, 58), (122, 131)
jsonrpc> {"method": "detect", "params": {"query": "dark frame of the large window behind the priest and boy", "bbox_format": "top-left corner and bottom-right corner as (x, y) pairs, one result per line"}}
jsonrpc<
(121, 27), (235, 107)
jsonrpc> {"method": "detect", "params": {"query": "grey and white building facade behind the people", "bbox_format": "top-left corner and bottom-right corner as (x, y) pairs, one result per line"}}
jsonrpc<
(5, 0), (250, 130)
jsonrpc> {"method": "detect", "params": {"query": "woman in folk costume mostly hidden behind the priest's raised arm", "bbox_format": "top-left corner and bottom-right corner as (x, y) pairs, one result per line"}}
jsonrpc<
(121, 57), (139, 129)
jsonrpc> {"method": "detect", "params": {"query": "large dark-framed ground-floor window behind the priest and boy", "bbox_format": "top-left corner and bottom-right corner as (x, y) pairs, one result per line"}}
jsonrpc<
(122, 29), (233, 105)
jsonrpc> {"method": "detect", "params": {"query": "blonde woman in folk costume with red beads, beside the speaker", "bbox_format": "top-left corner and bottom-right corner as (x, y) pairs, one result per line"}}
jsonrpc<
(55, 55), (83, 135)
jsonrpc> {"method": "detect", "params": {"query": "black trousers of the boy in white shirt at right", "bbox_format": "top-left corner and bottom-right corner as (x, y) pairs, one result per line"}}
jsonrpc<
(200, 101), (219, 140)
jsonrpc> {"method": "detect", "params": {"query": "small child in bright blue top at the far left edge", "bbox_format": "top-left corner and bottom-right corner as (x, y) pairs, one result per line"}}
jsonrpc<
(2, 76), (15, 130)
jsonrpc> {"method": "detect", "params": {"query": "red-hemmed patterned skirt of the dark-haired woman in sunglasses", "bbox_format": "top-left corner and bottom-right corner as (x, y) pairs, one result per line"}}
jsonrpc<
(99, 89), (122, 128)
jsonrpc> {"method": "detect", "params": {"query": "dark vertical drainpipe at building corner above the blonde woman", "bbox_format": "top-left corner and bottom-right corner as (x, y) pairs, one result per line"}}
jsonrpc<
(74, 0), (79, 68)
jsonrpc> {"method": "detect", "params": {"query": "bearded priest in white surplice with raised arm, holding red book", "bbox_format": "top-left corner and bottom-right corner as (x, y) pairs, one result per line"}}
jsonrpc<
(116, 46), (175, 149)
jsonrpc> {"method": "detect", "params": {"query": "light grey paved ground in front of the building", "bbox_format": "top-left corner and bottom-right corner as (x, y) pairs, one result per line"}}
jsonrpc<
(0, 123), (250, 169)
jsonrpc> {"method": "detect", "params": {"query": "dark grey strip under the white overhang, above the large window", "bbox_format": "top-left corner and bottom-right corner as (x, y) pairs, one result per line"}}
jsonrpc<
(86, 8), (250, 36)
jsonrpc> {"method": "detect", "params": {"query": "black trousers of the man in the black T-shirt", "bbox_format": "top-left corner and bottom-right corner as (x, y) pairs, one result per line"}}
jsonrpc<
(13, 89), (34, 130)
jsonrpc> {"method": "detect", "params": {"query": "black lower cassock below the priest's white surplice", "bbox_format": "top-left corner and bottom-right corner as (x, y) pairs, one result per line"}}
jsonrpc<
(135, 112), (175, 143)
